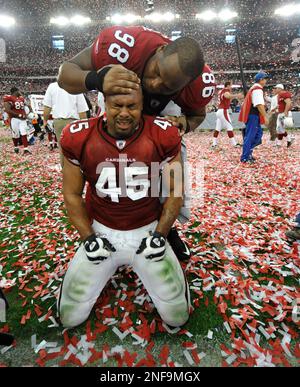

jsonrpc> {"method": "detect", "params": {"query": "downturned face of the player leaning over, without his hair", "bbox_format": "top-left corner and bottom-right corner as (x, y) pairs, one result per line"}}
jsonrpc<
(142, 50), (191, 95)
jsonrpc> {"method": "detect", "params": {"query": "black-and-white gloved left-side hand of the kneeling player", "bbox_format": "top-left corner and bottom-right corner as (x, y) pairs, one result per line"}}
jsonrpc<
(83, 234), (116, 265)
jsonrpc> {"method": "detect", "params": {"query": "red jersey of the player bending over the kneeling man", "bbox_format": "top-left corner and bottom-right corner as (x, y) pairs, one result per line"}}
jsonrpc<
(92, 26), (216, 114)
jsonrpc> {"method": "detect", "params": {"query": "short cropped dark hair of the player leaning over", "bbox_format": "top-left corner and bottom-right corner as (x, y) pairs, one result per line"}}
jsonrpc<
(163, 36), (204, 79)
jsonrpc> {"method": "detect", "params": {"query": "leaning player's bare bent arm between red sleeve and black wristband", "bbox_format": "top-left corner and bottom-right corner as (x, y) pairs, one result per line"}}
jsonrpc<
(58, 62), (89, 94)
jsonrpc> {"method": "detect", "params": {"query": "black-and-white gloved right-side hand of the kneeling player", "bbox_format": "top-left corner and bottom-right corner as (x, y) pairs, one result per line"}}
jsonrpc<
(136, 231), (166, 261)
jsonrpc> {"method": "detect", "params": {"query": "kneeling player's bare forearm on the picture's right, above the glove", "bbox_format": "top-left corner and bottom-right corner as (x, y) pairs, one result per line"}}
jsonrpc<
(155, 197), (183, 237)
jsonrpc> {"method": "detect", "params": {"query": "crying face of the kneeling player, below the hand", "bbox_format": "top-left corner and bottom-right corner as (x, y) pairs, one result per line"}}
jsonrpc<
(105, 88), (143, 140)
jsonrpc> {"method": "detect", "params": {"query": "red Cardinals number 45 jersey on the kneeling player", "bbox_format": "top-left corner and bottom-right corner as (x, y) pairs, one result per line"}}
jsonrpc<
(61, 115), (181, 230)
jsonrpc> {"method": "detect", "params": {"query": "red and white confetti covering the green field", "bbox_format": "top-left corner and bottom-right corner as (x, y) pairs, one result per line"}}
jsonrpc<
(0, 131), (300, 367)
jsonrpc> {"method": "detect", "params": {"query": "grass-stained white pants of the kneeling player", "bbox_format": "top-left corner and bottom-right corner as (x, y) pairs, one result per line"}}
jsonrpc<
(58, 221), (190, 328)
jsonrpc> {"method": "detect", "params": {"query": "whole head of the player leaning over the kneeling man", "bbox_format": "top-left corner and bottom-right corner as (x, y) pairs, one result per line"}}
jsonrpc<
(142, 37), (204, 95)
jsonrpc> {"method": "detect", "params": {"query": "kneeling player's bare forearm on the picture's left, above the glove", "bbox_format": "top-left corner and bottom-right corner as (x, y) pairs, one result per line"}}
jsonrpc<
(64, 194), (94, 240)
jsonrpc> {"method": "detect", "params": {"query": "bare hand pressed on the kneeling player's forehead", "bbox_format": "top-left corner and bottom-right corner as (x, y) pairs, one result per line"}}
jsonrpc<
(103, 65), (141, 95)
